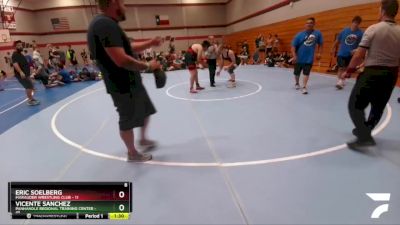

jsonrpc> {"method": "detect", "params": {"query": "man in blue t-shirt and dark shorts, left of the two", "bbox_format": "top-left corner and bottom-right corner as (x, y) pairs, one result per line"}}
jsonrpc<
(292, 18), (323, 94)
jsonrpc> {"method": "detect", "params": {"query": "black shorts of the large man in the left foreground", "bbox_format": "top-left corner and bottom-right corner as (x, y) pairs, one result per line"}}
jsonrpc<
(111, 88), (156, 131)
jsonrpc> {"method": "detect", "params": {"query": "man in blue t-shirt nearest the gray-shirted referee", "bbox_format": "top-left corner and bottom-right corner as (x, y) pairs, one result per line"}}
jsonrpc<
(331, 16), (363, 90)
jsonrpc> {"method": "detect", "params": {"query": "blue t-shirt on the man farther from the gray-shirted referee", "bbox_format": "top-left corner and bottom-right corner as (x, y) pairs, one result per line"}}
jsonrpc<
(292, 30), (324, 64)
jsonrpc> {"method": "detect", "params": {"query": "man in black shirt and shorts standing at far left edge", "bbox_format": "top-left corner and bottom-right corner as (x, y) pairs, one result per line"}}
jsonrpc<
(11, 41), (40, 106)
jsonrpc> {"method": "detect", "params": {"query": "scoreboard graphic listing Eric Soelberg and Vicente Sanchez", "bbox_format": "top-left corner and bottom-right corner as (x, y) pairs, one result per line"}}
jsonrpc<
(8, 182), (132, 220)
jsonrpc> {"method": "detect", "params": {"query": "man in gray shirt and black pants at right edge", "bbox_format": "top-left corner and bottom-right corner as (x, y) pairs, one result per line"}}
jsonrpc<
(342, 0), (400, 150)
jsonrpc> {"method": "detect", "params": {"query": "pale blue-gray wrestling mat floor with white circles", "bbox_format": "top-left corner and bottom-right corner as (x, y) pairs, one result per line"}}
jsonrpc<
(0, 66), (400, 224)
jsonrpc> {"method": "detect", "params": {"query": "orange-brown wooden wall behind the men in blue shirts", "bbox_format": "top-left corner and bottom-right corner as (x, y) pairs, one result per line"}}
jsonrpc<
(224, 0), (400, 85)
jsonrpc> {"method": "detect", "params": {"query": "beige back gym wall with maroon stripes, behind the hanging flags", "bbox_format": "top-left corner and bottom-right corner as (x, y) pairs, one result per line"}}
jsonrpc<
(0, 0), (226, 68)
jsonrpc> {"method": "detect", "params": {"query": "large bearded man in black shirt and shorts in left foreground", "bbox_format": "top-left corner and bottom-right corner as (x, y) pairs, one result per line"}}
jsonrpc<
(88, 0), (162, 162)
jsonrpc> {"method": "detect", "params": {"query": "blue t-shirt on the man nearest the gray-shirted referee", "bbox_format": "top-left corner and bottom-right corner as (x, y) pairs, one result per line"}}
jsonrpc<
(338, 28), (363, 57)
